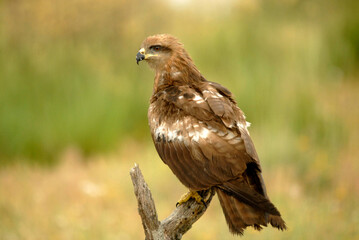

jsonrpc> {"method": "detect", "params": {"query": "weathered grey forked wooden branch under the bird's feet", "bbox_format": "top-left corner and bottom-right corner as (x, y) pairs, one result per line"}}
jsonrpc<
(130, 164), (214, 240)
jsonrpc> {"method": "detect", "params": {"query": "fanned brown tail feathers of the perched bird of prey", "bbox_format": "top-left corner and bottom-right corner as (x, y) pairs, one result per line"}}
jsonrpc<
(216, 188), (286, 234)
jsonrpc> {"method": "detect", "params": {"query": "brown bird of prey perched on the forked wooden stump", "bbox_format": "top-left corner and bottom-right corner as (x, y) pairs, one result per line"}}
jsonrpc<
(136, 34), (286, 234)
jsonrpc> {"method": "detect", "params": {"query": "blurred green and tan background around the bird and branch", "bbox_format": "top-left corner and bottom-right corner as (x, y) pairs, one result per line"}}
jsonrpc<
(0, 0), (359, 240)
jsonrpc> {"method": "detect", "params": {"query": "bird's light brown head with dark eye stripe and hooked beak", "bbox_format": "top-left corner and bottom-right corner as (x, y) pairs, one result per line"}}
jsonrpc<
(136, 34), (187, 70)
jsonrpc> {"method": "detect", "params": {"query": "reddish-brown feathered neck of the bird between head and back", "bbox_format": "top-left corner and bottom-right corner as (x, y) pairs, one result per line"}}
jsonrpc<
(153, 54), (204, 93)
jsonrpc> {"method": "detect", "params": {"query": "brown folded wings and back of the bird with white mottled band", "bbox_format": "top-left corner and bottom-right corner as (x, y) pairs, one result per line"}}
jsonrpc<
(153, 84), (259, 189)
